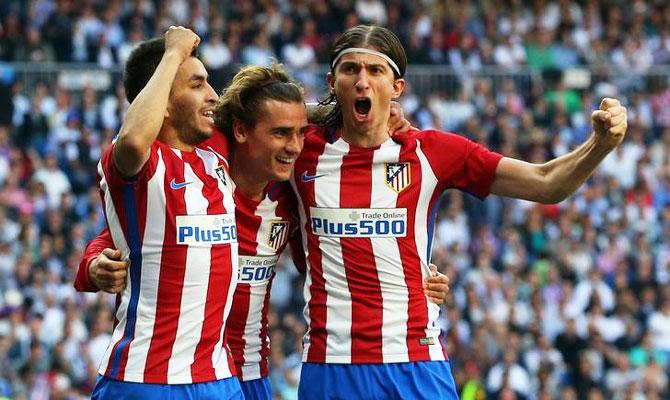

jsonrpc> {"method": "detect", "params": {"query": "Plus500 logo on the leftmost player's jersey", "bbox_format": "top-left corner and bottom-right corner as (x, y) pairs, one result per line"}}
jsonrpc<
(176, 214), (237, 246)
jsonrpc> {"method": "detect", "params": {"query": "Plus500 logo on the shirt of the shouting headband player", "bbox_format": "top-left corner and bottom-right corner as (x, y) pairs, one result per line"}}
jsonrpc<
(310, 207), (407, 237)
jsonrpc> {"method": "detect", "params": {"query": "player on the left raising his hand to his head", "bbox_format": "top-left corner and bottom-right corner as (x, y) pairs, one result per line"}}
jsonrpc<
(92, 26), (243, 400)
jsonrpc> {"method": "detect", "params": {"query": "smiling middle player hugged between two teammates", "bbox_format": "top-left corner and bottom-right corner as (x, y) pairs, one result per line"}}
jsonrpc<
(75, 60), (448, 400)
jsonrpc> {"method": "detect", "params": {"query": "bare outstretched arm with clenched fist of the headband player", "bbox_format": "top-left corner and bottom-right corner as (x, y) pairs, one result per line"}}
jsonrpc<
(491, 98), (628, 204)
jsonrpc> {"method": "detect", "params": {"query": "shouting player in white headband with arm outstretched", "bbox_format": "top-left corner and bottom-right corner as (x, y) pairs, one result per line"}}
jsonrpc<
(291, 26), (626, 399)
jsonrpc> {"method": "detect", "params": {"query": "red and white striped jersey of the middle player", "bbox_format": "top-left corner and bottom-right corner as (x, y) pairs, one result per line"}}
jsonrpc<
(226, 182), (302, 381)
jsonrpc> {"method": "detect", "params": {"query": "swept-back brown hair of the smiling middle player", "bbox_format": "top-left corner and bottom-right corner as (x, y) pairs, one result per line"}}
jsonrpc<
(214, 63), (305, 139)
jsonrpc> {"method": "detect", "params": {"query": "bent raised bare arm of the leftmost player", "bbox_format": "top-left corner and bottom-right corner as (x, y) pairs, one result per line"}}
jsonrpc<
(114, 26), (200, 178)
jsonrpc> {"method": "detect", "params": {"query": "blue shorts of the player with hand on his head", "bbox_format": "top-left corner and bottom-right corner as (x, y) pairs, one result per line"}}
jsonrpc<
(91, 375), (244, 400)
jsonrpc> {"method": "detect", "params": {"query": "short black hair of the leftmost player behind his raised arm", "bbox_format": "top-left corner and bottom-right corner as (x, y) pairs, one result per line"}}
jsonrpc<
(123, 37), (198, 103)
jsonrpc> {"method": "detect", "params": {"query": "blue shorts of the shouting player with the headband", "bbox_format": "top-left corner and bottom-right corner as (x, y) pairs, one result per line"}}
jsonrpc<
(298, 361), (458, 400)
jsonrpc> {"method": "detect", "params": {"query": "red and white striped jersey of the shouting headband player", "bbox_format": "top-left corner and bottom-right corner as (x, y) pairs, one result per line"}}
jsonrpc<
(291, 128), (501, 363)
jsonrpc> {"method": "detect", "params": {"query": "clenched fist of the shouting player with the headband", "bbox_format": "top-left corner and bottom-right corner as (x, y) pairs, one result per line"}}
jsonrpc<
(591, 97), (628, 150)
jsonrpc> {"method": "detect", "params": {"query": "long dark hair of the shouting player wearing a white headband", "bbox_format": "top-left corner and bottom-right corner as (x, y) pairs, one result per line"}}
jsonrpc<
(319, 25), (407, 127)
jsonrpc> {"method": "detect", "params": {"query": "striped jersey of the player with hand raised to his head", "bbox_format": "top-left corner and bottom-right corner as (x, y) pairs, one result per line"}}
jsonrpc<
(98, 141), (238, 384)
